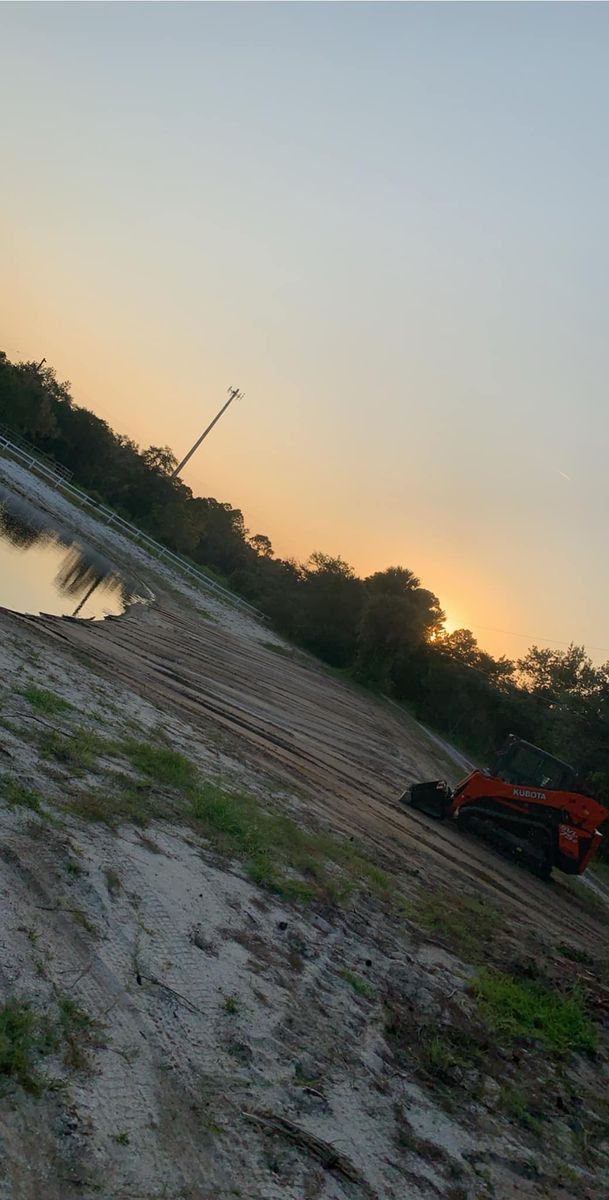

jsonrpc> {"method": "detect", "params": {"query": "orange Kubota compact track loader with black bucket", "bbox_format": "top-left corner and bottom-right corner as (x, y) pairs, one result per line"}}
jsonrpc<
(402, 737), (609, 877)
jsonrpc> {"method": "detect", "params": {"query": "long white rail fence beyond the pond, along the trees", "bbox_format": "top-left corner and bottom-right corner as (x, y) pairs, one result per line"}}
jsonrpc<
(0, 427), (267, 620)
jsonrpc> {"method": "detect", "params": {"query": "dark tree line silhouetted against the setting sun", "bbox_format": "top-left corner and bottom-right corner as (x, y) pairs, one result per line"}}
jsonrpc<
(0, 353), (609, 820)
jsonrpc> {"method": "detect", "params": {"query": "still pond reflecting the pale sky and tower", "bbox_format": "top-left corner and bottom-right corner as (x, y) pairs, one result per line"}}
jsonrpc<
(0, 486), (141, 620)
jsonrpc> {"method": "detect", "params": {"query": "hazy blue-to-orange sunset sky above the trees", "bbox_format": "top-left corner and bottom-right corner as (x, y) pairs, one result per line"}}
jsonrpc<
(0, 2), (609, 661)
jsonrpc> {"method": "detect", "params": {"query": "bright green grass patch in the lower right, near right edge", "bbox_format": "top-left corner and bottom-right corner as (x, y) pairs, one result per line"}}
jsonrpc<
(474, 970), (597, 1056)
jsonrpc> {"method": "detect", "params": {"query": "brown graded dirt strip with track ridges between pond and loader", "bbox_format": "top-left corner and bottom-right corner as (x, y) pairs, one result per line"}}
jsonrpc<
(17, 605), (605, 946)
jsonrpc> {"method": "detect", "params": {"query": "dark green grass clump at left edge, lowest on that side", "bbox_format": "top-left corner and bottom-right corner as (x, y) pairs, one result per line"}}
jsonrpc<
(0, 997), (58, 1096)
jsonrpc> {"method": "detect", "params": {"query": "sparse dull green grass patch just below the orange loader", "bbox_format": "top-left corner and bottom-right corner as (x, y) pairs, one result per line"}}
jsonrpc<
(404, 893), (499, 961)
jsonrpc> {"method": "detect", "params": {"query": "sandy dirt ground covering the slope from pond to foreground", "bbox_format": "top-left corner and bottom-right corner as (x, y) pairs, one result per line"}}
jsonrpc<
(0, 453), (609, 1200)
